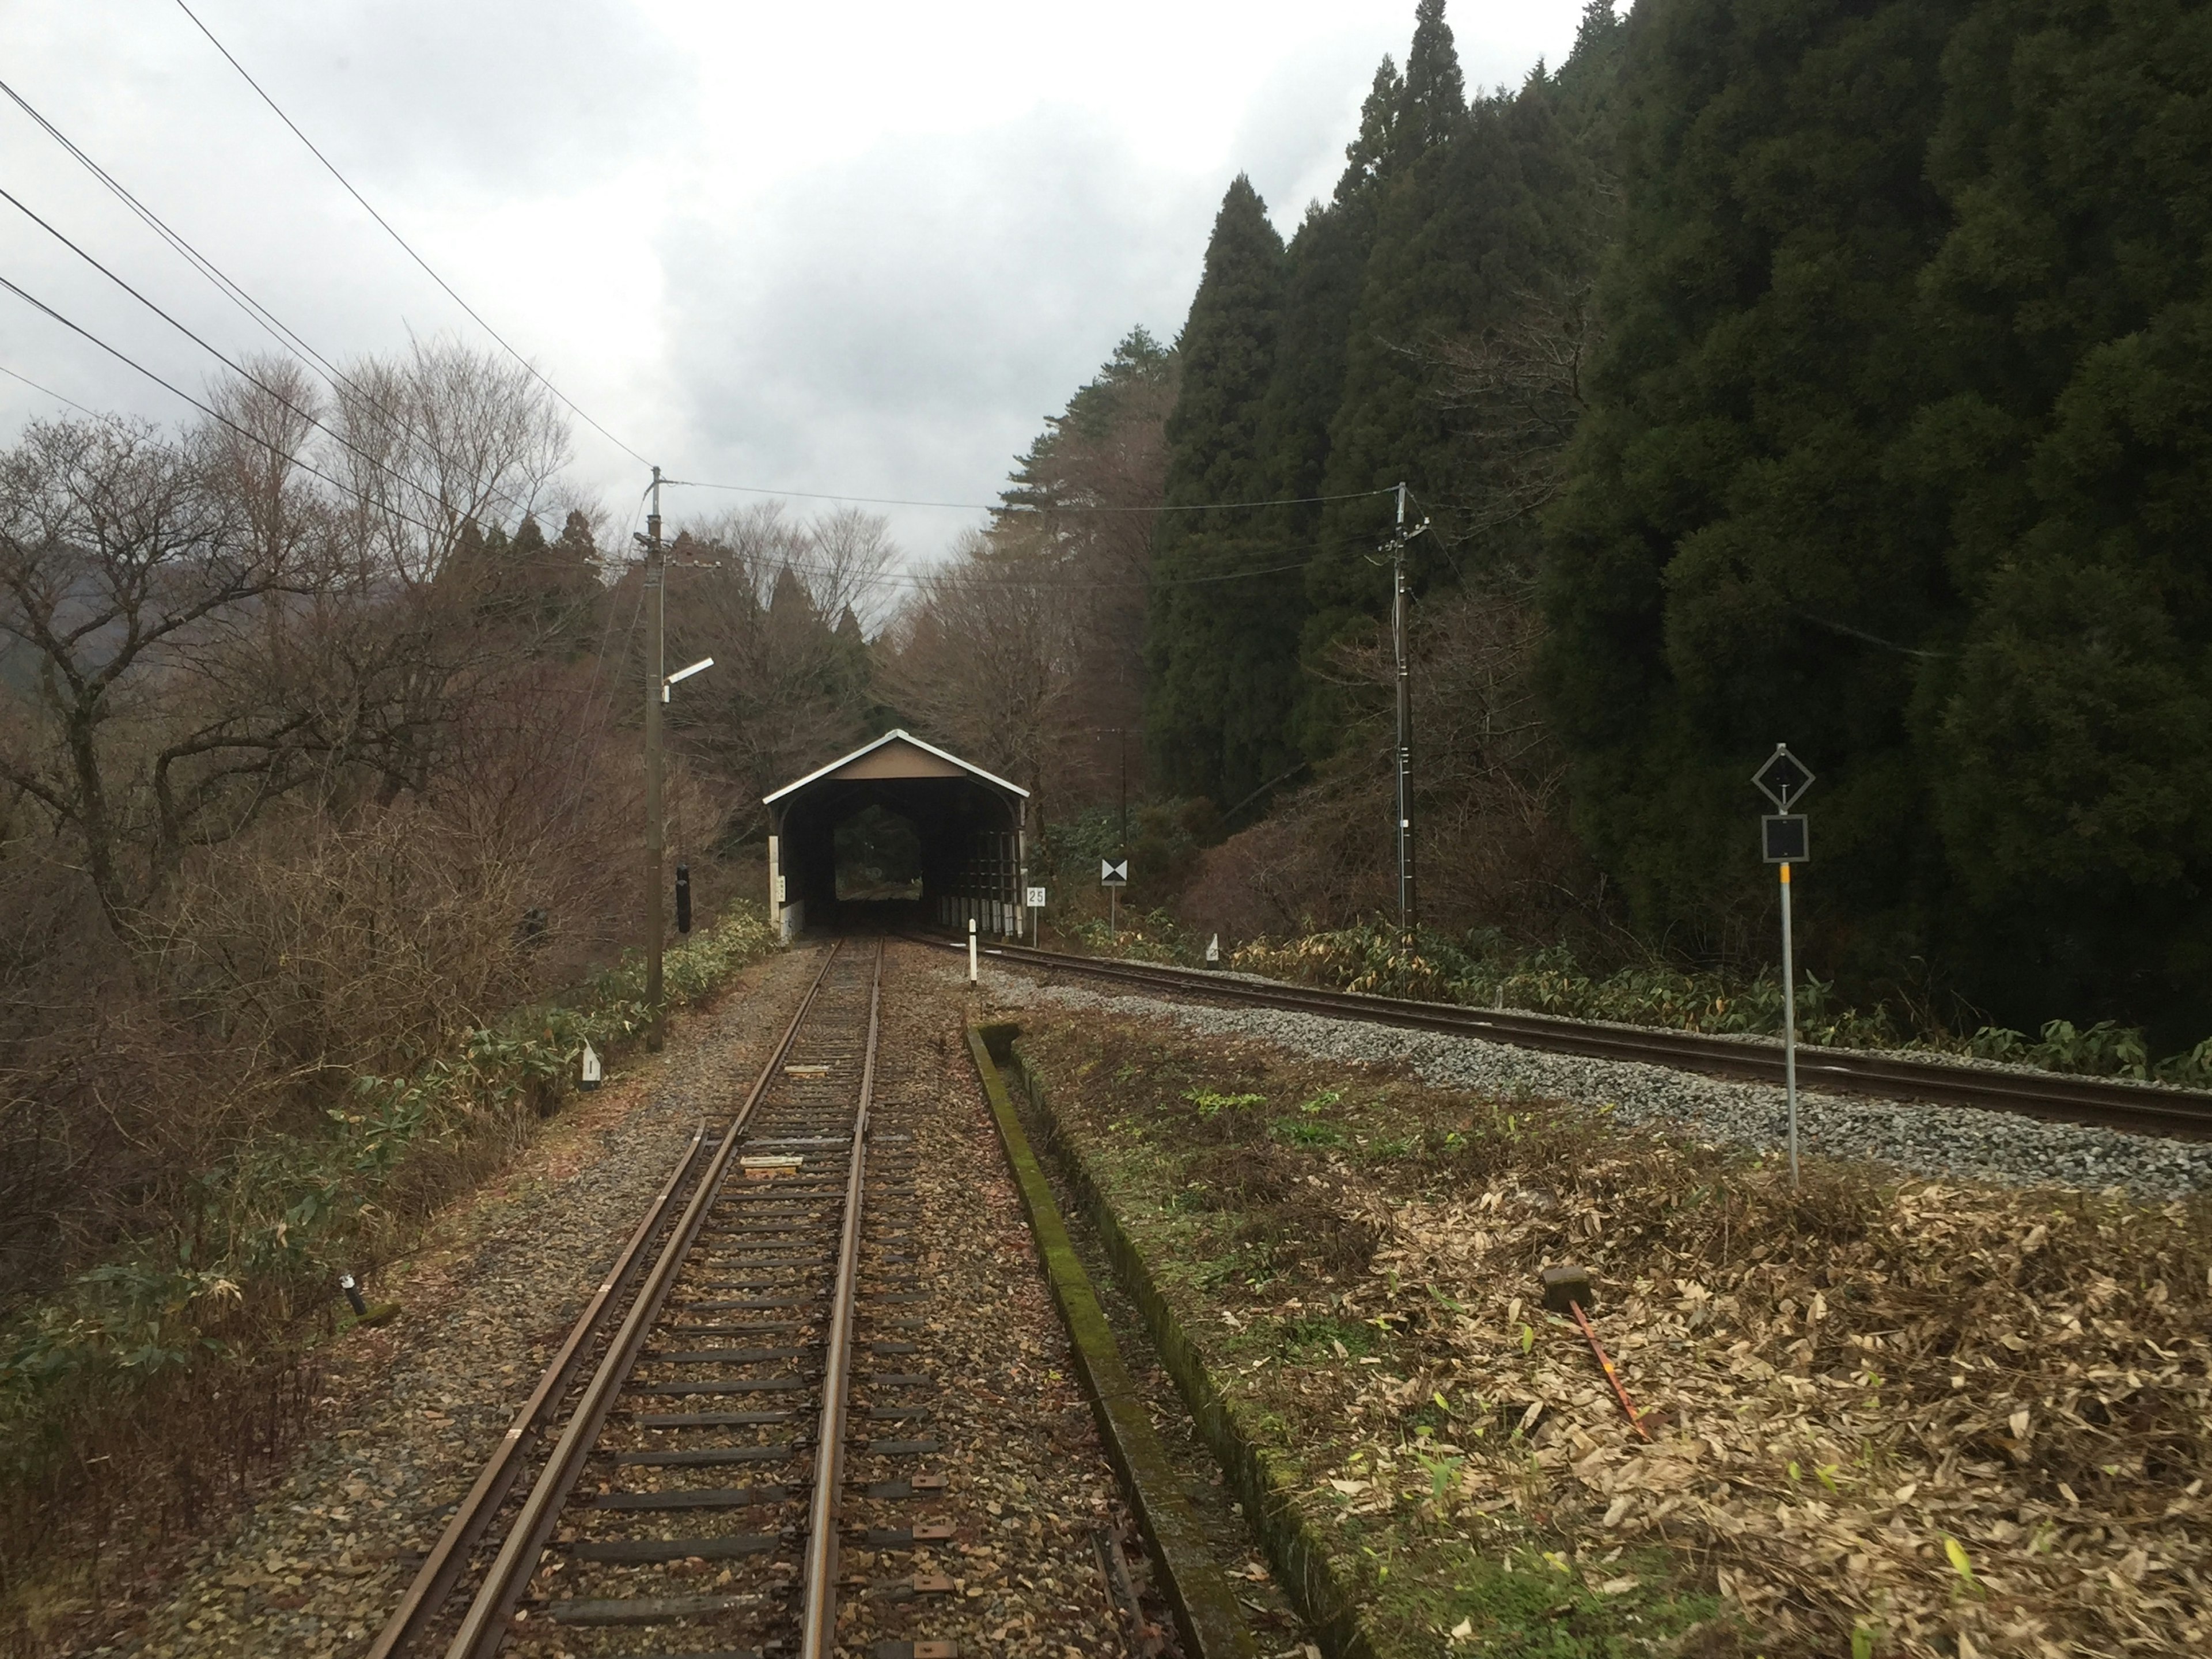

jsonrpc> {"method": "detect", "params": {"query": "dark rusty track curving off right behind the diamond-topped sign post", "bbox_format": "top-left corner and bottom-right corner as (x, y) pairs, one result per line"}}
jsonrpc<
(929, 940), (2212, 1139)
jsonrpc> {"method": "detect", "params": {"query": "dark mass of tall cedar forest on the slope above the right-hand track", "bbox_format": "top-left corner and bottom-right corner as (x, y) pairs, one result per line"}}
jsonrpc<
(1143, 0), (2212, 1037)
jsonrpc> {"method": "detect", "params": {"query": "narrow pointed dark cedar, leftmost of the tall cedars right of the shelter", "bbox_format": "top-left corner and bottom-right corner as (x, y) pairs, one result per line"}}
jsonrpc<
(1146, 175), (1301, 808)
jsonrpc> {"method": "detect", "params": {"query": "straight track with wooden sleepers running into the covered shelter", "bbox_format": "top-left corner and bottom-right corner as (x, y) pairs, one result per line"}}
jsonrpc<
(369, 940), (956, 1659)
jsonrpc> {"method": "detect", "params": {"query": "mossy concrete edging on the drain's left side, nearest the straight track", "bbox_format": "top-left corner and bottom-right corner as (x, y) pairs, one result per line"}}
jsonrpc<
(967, 1027), (1259, 1659)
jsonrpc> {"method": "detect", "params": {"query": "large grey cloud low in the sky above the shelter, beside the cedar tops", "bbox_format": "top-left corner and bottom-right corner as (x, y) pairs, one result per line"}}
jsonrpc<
(661, 111), (1217, 551)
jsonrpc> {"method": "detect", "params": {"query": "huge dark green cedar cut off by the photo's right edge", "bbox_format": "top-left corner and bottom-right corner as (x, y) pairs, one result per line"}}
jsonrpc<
(1911, 0), (2212, 1042)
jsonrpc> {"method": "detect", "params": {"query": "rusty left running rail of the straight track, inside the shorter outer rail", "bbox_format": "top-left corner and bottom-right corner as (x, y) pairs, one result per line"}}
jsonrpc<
(447, 942), (843, 1659)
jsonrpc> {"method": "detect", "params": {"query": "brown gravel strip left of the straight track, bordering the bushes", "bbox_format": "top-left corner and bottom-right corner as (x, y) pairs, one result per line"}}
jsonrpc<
(93, 951), (821, 1659)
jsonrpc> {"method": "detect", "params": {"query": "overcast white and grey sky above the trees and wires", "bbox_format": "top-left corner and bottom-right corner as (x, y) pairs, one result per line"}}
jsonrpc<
(0, 0), (1582, 558)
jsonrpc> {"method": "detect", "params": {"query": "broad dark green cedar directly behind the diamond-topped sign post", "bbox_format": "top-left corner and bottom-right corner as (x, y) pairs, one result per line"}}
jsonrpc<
(1546, 0), (1964, 973)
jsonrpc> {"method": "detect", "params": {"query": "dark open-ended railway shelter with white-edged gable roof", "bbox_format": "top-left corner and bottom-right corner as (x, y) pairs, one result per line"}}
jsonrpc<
(763, 732), (1029, 940)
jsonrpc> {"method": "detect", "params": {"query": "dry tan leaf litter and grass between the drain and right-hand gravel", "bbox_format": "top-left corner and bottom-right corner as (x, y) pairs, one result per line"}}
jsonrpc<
(1024, 1016), (2212, 1659)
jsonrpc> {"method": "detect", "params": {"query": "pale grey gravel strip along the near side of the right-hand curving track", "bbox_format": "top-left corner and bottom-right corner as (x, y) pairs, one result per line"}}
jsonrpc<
(964, 964), (2212, 1201)
